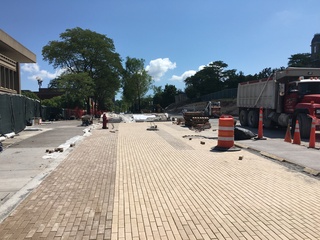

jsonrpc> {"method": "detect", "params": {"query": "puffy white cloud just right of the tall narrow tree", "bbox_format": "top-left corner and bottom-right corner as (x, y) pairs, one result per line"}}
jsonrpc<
(146, 58), (176, 81)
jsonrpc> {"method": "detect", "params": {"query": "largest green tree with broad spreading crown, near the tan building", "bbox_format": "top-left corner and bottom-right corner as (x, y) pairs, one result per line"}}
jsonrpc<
(42, 27), (123, 111)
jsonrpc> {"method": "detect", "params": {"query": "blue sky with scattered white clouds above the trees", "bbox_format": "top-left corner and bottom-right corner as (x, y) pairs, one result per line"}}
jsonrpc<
(0, 0), (320, 95)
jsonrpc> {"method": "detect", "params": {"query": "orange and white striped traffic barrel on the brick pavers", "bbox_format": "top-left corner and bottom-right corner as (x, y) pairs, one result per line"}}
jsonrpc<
(214, 115), (240, 151)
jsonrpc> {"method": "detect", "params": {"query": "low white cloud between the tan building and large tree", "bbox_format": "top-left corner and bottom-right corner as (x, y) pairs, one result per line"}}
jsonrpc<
(21, 63), (64, 81)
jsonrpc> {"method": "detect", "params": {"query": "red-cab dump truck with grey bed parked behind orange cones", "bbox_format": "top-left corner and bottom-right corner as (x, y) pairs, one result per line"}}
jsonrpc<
(237, 67), (320, 138)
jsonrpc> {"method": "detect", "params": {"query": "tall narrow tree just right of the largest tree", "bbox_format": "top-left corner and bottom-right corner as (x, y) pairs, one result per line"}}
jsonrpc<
(122, 57), (152, 112)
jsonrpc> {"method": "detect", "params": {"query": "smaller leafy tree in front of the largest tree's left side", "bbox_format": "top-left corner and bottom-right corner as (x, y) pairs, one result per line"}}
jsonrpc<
(49, 72), (94, 108)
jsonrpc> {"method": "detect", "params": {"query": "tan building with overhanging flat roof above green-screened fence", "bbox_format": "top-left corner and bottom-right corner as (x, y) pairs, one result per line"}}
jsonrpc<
(0, 29), (36, 94)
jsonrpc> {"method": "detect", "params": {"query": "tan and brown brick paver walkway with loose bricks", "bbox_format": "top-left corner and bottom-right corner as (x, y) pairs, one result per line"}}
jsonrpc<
(0, 122), (320, 239)
